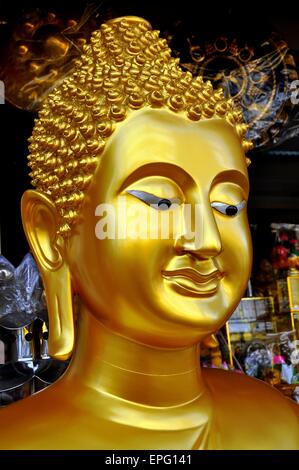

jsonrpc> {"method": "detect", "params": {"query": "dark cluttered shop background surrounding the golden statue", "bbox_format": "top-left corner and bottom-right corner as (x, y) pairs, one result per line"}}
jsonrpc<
(0, 0), (299, 406)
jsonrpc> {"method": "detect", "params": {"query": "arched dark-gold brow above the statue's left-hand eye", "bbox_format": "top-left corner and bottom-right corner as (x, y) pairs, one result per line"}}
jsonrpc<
(118, 162), (194, 193)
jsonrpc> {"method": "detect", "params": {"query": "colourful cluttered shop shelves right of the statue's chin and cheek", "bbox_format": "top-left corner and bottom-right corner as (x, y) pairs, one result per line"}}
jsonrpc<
(210, 223), (299, 402)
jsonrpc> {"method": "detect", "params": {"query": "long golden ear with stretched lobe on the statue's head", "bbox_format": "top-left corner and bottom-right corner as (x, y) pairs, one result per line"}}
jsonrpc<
(21, 190), (74, 360)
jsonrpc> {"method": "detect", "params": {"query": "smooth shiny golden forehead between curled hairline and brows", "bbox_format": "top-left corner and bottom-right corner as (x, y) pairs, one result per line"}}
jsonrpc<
(96, 109), (247, 191)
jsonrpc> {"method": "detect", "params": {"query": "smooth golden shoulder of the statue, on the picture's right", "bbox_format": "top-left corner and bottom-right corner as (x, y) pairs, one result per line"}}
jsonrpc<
(203, 369), (299, 449)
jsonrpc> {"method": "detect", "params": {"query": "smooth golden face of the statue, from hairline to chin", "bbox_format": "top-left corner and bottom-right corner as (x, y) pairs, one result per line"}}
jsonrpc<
(68, 109), (251, 347)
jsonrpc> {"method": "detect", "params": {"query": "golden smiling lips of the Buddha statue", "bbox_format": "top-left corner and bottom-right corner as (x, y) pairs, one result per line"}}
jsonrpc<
(162, 268), (223, 297)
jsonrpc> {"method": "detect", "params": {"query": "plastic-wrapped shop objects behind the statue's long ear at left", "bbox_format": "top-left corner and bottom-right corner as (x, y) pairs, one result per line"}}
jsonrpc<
(0, 253), (68, 407)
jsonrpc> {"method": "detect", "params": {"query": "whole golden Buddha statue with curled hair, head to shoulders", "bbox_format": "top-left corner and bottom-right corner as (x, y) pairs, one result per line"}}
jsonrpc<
(0, 17), (299, 449)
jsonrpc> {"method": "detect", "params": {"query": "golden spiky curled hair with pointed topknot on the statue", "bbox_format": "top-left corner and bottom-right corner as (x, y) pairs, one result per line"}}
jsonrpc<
(28, 17), (252, 236)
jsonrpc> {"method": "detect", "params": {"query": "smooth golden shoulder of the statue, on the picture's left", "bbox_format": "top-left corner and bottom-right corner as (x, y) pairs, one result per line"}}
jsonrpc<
(0, 380), (143, 450)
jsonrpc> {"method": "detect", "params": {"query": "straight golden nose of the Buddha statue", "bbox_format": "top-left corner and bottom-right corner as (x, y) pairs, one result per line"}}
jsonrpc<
(175, 202), (222, 259)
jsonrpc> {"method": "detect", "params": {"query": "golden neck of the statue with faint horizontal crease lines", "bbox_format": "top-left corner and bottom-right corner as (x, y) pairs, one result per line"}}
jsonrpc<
(68, 306), (209, 407)
